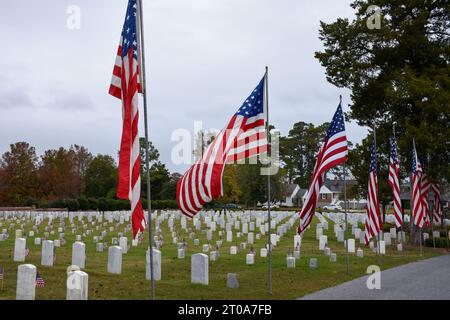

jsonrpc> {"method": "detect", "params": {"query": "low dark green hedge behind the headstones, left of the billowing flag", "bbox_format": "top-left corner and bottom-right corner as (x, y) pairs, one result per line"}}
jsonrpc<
(40, 197), (178, 211)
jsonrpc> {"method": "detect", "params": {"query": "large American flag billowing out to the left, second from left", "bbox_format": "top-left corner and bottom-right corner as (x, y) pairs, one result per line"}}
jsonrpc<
(177, 76), (268, 217)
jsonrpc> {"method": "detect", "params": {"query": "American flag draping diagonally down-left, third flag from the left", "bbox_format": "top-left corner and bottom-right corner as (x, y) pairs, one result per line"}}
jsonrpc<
(298, 104), (348, 234)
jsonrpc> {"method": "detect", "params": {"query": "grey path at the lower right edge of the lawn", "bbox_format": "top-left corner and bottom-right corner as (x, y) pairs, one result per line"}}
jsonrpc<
(300, 255), (450, 300)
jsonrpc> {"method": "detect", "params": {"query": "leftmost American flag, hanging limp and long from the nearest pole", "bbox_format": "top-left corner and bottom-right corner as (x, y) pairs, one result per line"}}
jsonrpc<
(109, 0), (146, 237)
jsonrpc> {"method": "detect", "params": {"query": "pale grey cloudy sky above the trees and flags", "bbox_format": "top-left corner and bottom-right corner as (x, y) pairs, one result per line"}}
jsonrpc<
(0, 0), (366, 172)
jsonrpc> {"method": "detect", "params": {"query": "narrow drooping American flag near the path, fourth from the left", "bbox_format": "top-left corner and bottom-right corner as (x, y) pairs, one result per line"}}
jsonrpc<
(365, 137), (383, 245)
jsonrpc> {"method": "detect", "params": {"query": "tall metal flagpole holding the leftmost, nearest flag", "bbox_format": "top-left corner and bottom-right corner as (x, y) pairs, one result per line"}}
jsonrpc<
(136, 0), (156, 300)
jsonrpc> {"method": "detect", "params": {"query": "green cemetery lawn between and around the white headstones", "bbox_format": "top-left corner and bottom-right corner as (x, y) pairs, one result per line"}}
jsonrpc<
(0, 212), (446, 300)
